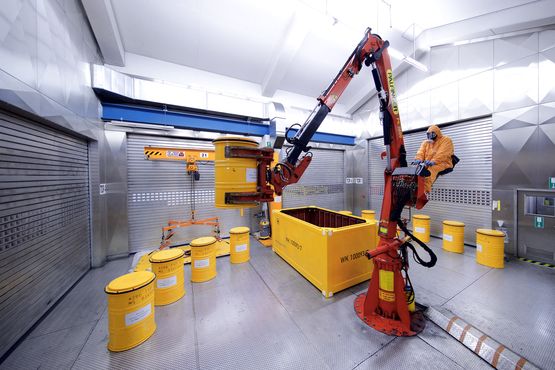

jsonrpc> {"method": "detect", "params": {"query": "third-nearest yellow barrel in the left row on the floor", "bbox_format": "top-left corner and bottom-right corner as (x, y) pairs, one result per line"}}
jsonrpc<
(190, 236), (218, 283)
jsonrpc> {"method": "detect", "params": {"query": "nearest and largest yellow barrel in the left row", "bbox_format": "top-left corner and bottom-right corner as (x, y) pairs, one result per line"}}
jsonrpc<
(104, 271), (156, 352)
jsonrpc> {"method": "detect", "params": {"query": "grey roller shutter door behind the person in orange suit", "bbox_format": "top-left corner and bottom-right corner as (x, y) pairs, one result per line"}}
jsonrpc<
(368, 118), (492, 244)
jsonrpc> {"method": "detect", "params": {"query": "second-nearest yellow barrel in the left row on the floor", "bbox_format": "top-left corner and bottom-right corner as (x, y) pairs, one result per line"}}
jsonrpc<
(149, 248), (185, 306)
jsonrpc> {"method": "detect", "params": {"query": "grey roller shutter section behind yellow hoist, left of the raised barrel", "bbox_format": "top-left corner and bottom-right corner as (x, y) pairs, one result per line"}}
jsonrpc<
(127, 134), (251, 252)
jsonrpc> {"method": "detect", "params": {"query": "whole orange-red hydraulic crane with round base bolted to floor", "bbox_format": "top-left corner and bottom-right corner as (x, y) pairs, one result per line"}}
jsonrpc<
(266, 28), (437, 336)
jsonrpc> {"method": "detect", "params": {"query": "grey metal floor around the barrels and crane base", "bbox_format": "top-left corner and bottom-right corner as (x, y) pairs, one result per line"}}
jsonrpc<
(0, 239), (555, 370)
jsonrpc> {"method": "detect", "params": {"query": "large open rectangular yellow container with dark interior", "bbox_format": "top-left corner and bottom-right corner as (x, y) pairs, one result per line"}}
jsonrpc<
(272, 207), (376, 297)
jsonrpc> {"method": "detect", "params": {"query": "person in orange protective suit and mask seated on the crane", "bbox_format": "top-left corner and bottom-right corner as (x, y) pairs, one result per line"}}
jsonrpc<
(414, 125), (455, 193)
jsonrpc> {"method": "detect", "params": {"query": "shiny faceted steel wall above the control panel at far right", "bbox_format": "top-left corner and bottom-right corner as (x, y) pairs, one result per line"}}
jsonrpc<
(493, 30), (555, 254)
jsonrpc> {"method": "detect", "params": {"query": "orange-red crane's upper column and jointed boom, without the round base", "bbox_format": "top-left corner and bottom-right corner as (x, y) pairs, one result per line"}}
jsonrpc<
(271, 28), (426, 238)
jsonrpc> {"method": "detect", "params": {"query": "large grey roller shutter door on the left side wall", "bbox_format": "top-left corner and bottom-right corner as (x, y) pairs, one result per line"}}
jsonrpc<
(0, 112), (90, 355)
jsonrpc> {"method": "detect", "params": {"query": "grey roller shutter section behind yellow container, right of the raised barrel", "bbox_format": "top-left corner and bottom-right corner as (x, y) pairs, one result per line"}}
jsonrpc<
(283, 149), (345, 211)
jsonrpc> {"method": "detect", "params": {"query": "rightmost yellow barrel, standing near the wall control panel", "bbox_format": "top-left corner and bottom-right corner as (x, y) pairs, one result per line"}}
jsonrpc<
(476, 229), (505, 269)
